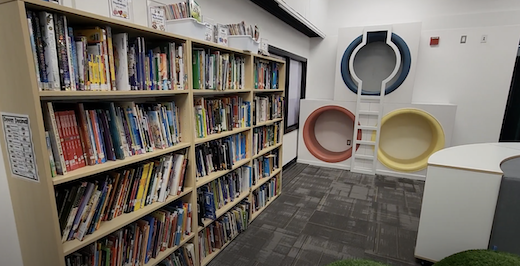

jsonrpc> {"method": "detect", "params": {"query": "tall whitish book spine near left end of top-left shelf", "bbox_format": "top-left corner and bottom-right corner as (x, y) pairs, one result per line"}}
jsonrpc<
(40, 11), (61, 91)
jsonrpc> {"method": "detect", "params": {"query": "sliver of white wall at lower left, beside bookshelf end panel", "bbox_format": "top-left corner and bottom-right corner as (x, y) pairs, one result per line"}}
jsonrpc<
(0, 150), (23, 266)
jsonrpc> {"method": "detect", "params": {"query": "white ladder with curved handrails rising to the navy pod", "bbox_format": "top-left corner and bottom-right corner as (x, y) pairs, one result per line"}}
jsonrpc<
(349, 28), (401, 175)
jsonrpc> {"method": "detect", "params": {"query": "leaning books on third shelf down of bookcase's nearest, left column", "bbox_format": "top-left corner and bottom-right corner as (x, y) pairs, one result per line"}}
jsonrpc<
(55, 154), (188, 242)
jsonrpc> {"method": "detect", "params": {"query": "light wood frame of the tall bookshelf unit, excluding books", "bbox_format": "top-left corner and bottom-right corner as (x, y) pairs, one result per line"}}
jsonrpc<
(0, 0), (285, 266)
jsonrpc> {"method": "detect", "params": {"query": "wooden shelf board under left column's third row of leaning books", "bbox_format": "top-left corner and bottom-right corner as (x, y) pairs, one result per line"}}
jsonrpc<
(63, 187), (193, 256)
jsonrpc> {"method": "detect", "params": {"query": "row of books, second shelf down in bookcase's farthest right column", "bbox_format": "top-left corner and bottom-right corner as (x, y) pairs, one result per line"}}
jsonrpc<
(253, 95), (284, 125)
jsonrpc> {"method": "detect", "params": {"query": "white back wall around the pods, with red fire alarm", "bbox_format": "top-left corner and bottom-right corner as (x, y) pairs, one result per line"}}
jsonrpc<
(306, 0), (520, 145)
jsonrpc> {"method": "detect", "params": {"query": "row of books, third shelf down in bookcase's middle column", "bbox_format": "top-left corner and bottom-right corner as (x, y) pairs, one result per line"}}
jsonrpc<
(195, 133), (249, 179)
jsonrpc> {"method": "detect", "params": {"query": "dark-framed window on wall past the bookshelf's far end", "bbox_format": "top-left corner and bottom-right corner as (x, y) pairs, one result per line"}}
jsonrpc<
(269, 46), (307, 133)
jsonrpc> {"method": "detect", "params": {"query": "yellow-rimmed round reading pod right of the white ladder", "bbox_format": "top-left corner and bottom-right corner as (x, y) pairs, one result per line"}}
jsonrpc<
(372, 108), (445, 172)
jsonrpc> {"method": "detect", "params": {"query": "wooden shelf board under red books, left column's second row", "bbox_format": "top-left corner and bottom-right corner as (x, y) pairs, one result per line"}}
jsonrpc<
(52, 143), (190, 186)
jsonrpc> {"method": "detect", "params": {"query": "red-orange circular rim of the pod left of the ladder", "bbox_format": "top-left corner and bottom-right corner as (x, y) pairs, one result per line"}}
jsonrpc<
(303, 105), (361, 163)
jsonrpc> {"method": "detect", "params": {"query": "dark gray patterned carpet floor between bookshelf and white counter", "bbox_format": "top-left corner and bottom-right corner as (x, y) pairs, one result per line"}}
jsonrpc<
(209, 164), (424, 266)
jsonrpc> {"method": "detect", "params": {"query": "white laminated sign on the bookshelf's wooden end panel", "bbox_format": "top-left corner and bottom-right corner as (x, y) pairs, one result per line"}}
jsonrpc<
(1, 113), (39, 181)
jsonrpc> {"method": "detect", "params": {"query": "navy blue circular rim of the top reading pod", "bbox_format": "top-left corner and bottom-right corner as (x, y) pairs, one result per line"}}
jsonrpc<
(340, 32), (412, 95)
